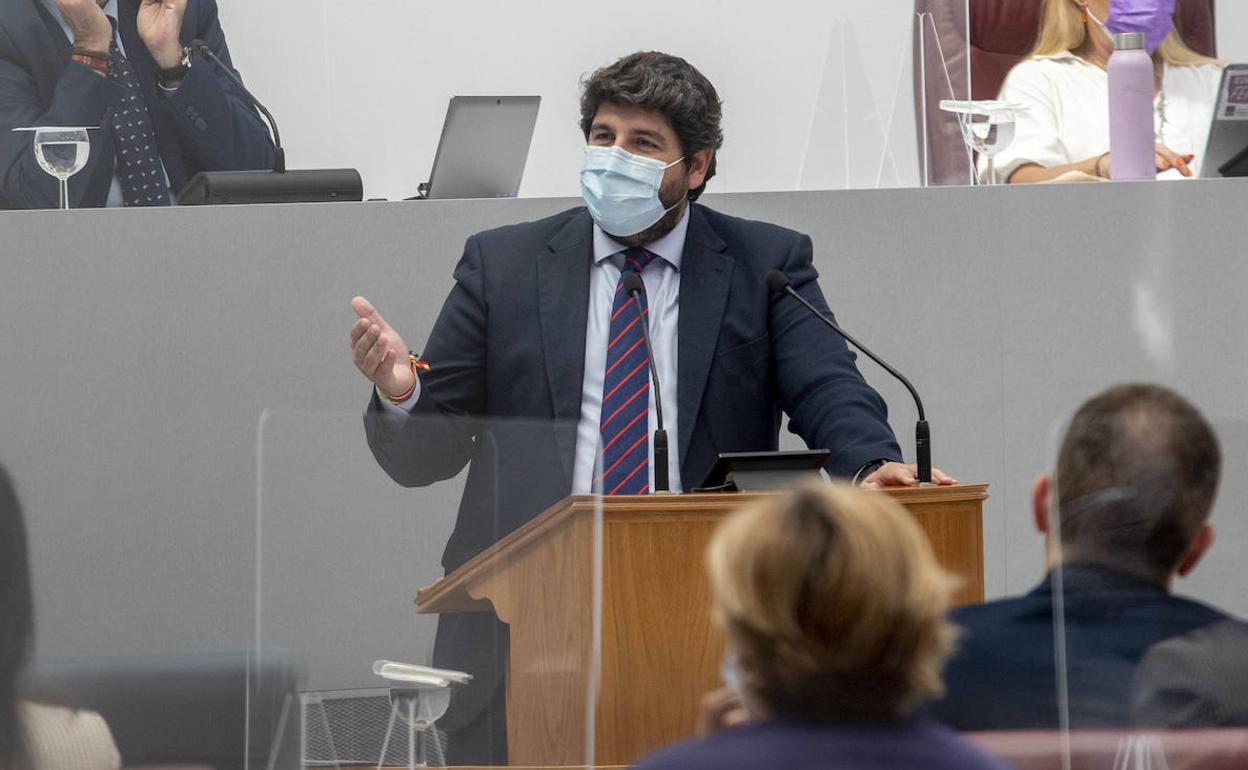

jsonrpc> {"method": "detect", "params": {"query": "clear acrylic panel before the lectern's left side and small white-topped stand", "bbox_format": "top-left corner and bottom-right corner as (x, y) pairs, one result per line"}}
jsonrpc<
(248, 409), (602, 768)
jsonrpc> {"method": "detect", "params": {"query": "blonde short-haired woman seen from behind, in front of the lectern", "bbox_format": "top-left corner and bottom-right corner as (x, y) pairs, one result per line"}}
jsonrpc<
(638, 484), (1007, 770)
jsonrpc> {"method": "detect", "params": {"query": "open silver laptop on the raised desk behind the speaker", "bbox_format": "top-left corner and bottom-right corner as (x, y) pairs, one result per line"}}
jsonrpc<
(419, 96), (542, 200)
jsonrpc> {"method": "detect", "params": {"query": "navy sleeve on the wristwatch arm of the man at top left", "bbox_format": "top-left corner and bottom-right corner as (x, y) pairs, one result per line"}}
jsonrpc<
(157, 0), (273, 171)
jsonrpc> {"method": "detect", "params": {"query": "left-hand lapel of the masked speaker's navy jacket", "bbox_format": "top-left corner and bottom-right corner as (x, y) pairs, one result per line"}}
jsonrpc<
(538, 212), (594, 478)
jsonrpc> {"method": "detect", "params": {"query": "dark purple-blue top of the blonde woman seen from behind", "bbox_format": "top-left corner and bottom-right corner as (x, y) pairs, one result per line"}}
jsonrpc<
(635, 720), (1010, 770)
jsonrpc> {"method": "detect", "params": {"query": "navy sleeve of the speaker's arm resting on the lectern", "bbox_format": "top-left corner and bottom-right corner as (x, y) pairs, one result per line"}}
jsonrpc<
(771, 236), (901, 478)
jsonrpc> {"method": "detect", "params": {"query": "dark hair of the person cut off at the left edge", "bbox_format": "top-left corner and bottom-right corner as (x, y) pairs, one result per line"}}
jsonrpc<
(0, 465), (34, 770)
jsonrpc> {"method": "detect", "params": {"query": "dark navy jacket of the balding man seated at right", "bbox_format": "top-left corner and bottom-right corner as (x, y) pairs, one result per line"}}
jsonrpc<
(930, 565), (1227, 730)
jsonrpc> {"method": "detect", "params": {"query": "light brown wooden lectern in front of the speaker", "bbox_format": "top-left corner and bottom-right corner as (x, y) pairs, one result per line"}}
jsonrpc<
(417, 484), (988, 766)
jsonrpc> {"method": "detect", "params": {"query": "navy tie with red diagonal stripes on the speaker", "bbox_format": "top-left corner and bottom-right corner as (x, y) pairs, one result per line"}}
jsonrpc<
(599, 248), (654, 494)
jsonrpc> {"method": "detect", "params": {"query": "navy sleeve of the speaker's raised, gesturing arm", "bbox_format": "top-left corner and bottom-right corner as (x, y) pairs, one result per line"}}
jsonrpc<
(364, 237), (487, 487)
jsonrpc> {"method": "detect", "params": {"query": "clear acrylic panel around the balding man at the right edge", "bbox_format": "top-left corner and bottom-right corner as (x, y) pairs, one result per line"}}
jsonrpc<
(1035, 411), (1248, 770)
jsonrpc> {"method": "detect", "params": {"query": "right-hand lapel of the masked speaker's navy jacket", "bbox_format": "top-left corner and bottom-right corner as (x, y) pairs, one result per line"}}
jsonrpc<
(676, 206), (733, 474)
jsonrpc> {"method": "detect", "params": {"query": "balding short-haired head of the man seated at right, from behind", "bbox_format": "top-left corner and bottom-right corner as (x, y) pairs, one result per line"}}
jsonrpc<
(1035, 384), (1222, 584)
